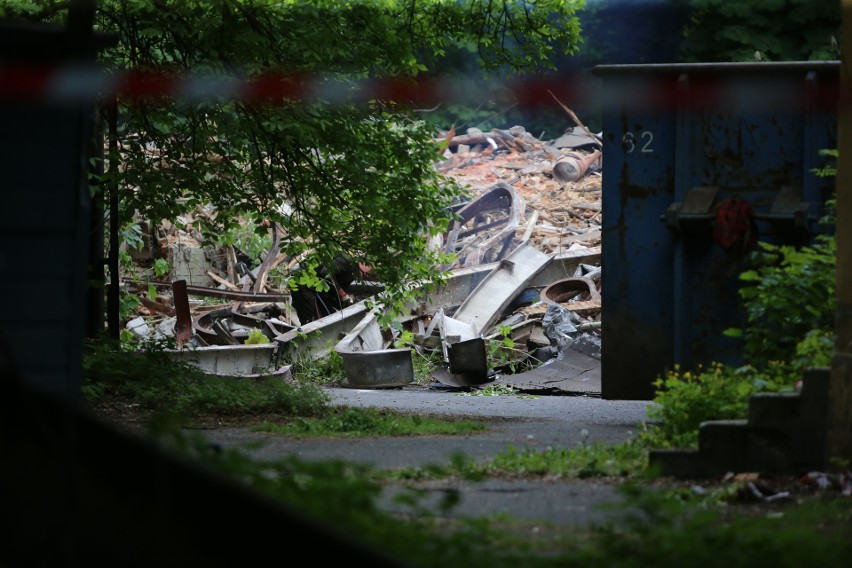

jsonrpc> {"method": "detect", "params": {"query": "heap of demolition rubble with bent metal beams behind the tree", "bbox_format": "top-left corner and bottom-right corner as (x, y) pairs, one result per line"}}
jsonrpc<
(122, 122), (603, 393)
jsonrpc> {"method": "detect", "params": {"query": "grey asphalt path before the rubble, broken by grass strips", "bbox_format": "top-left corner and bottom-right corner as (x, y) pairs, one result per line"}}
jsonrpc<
(200, 386), (650, 526)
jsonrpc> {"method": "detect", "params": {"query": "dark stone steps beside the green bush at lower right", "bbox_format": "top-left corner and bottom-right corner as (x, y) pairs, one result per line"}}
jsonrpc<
(649, 367), (830, 479)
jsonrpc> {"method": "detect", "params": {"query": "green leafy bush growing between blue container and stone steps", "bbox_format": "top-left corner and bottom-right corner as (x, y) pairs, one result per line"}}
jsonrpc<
(643, 231), (836, 447)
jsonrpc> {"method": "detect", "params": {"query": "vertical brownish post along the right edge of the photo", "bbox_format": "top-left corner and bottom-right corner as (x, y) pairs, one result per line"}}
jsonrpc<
(826, 0), (852, 464)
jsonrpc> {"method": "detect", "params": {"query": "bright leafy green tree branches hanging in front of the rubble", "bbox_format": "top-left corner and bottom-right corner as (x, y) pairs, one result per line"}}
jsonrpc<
(0, 0), (583, 322)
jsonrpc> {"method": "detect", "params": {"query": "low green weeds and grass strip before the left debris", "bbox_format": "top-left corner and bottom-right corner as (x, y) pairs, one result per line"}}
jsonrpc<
(82, 342), (485, 436)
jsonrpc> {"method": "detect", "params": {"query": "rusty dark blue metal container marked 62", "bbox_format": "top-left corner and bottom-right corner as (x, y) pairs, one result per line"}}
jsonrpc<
(593, 61), (839, 400)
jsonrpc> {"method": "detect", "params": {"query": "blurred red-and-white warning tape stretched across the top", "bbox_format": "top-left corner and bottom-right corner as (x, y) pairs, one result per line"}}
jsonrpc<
(0, 62), (850, 110)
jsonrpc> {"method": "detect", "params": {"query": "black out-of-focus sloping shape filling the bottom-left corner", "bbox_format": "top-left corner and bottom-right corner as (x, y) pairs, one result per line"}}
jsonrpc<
(0, 344), (399, 568)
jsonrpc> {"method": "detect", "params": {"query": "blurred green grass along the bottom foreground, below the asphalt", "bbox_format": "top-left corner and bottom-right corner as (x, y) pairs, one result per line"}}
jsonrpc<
(161, 430), (852, 568)
